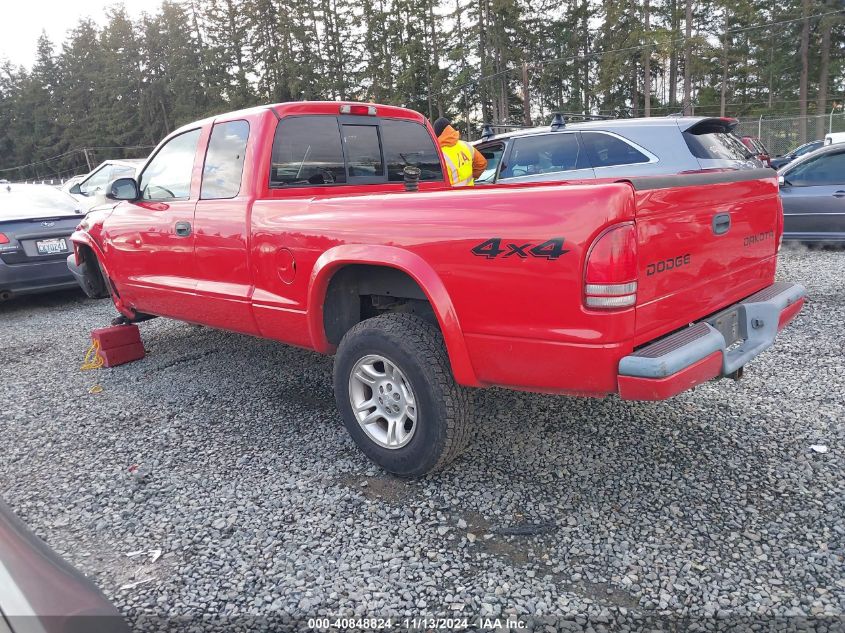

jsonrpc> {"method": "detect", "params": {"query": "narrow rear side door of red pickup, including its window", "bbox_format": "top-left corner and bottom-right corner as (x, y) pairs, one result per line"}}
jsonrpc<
(193, 119), (258, 334)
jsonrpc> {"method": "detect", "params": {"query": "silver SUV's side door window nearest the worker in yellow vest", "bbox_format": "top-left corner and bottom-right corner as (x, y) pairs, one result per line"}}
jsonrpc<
(499, 132), (590, 180)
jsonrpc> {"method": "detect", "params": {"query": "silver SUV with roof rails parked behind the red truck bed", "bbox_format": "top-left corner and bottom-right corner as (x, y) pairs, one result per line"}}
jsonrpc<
(473, 114), (764, 184)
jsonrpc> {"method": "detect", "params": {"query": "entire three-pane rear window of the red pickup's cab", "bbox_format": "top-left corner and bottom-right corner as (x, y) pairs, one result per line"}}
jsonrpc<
(270, 115), (443, 189)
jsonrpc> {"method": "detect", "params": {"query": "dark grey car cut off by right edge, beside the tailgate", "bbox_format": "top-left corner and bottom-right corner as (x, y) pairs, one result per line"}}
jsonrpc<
(779, 143), (845, 243)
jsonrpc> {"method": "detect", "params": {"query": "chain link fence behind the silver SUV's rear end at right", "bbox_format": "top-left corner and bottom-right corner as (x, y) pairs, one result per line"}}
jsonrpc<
(736, 112), (845, 156)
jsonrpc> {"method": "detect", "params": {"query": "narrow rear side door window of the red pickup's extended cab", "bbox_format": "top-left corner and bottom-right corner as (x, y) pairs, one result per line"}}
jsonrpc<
(200, 121), (249, 200)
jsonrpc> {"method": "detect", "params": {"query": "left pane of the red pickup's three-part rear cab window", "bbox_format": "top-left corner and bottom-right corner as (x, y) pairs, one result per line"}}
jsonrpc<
(270, 116), (346, 187)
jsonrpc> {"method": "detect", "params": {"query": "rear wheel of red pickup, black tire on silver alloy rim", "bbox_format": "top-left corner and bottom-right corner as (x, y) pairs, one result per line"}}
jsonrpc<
(334, 313), (472, 477)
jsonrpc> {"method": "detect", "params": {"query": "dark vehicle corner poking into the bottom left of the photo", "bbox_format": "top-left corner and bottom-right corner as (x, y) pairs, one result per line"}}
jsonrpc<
(0, 501), (129, 633)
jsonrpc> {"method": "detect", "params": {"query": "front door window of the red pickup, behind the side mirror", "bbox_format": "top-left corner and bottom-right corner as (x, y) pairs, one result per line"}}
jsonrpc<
(139, 129), (200, 200)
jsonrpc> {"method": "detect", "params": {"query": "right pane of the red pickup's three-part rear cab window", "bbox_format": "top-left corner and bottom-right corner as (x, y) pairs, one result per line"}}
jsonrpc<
(381, 119), (443, 182)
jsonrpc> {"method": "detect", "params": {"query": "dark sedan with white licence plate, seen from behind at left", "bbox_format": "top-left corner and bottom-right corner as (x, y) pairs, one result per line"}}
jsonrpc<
(0, 184), (82, 301)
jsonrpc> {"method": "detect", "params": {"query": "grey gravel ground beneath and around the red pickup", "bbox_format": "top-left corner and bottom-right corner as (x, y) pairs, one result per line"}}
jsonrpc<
(0, 249), (845, 631)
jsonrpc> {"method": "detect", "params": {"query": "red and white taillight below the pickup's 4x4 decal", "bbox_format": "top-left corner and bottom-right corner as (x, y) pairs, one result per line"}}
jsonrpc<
(584, 224), (637, 310)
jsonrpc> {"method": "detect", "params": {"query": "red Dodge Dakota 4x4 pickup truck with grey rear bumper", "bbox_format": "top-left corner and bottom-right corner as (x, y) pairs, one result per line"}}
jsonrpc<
(68, 102), (804, 476)
